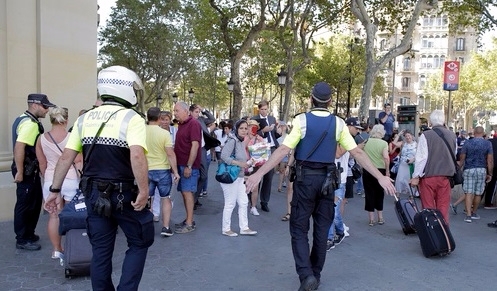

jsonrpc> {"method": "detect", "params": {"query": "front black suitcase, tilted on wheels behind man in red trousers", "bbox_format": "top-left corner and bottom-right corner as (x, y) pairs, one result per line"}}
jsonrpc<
(414, 209), (456, 258)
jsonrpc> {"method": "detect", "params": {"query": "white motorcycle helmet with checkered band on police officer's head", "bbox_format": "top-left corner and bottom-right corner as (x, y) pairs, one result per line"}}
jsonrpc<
(97, 66), (144, 107)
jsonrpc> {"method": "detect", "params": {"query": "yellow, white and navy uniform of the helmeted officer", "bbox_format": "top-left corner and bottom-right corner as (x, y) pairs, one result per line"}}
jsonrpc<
(71, 103), (154, 290)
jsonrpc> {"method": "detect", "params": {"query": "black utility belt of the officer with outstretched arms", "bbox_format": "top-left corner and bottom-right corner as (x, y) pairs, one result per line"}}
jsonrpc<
(295, 160), (340, 196)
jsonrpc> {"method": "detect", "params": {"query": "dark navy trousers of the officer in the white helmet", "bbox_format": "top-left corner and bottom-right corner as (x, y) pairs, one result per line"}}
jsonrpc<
(85, 187), (155, 291)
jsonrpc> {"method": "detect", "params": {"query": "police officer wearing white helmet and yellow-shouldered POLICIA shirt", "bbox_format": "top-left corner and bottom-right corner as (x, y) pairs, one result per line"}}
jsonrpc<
(45, 66), (154, 290)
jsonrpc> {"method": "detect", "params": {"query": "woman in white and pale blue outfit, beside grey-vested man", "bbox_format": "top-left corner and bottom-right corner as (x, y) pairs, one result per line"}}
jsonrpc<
(393, 130), (417, 195)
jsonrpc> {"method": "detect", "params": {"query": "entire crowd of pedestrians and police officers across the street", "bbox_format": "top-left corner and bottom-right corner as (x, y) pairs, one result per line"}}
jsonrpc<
(12, 66), (497, 290)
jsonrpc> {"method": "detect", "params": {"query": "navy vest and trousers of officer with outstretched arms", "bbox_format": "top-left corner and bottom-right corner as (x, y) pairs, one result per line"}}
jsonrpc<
(290, 113), (337, 281)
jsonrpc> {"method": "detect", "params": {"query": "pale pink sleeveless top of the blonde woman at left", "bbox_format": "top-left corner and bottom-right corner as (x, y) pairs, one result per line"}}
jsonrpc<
(40, 134), (79, 181)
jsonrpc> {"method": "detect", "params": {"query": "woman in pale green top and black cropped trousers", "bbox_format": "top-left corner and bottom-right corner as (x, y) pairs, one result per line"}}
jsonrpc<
(362, 124), (390, 226)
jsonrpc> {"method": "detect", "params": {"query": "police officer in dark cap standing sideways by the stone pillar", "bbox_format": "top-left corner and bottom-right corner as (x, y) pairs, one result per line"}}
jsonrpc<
(11, 94), (55, 251)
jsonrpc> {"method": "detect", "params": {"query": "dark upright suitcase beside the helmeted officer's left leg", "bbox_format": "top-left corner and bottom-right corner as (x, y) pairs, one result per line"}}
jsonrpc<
(64, 229), (92, 278)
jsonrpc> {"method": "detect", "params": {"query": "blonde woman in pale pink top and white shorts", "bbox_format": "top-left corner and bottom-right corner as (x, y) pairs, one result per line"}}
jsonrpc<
(36, 107), (82, 260)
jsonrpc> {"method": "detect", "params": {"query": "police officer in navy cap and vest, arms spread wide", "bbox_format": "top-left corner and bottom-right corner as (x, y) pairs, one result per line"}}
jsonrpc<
(246, 82), (395, 290)
